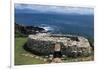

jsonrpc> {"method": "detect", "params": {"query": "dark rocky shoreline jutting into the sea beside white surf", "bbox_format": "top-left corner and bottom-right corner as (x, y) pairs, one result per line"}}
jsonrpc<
(15, 23), (46, 36)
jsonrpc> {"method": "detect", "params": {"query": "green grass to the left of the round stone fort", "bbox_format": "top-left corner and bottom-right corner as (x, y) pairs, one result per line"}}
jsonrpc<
(15, 37), (44, 65)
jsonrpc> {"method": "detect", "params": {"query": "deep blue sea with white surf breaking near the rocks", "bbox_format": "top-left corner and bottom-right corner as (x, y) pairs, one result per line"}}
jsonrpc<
(15, 13), (94, 37)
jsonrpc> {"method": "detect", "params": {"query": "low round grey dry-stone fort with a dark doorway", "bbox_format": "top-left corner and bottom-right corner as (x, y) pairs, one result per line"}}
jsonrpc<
(27, 33), (91, 57)
